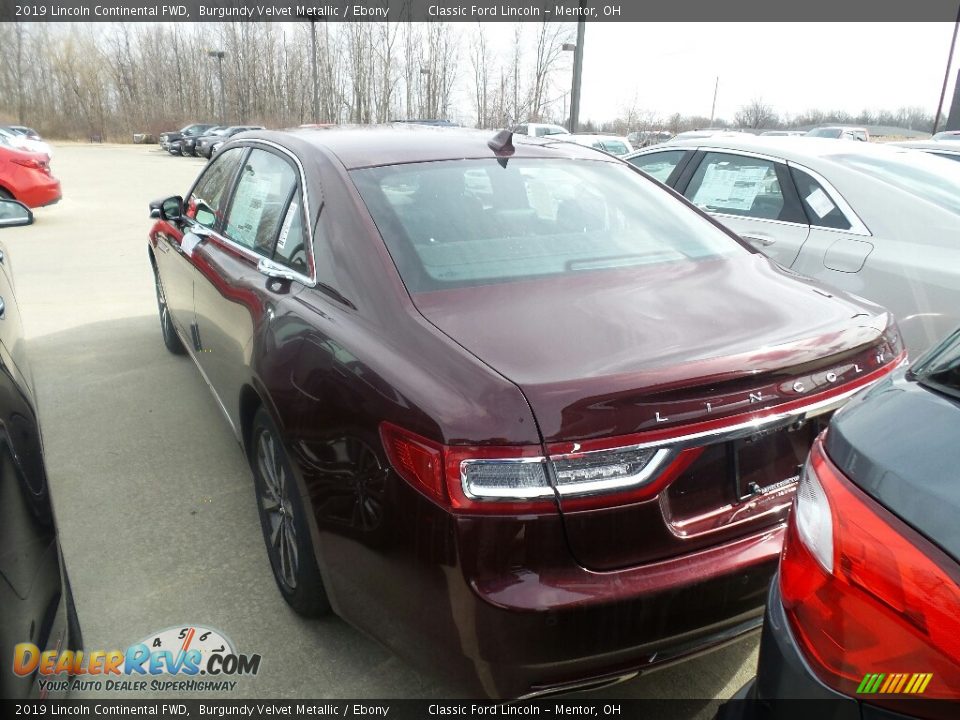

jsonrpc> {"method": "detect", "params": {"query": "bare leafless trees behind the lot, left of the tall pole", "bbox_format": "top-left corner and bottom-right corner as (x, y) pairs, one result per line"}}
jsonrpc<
(0, 22), (572, 140)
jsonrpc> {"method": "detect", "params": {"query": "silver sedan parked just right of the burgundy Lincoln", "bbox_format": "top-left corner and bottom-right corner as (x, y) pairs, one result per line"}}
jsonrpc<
(625, 137), (960, 357)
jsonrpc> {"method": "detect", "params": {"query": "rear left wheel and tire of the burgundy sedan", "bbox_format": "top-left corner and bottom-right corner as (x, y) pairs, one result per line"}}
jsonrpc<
(249, 407), (331, 617)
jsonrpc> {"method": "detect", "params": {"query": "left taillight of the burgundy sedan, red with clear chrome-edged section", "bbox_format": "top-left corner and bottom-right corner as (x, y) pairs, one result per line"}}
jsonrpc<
(380, 423), (688, 513)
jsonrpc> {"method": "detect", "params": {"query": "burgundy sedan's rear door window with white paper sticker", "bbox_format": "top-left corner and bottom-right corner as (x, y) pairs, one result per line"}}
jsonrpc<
(224, 148), (297, 257)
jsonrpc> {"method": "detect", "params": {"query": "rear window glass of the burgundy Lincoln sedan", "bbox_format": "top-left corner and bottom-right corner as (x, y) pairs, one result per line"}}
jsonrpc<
(351, 158), (748, 293)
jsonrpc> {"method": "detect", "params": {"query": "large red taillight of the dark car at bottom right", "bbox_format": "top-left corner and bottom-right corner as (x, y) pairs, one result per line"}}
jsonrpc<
(780, 438), (960, 702)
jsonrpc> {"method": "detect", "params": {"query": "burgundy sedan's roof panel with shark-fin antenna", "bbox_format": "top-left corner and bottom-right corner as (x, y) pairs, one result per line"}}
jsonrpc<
(244, 124), (606, 170)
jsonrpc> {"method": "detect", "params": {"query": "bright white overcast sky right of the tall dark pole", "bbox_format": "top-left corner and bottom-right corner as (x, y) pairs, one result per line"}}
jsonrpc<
(478, 22), (960, 121)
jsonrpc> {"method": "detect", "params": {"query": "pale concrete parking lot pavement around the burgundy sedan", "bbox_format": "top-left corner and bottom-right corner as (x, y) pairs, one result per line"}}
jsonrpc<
(2, 145), (757, 717)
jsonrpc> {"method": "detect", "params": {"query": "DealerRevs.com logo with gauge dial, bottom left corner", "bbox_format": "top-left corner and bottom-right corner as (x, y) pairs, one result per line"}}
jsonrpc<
(13, 625), (261, 692)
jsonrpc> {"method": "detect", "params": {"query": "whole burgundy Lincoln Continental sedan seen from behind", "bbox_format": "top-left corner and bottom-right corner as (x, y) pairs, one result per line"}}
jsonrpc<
(149, 127), (904, 697)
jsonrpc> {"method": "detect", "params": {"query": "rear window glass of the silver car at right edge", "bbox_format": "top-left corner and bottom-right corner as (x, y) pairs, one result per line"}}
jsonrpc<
(830, 150), (960, 215)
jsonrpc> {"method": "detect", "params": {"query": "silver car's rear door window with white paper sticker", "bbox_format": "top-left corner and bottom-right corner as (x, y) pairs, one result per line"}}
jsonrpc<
(684, 152), (806, 224)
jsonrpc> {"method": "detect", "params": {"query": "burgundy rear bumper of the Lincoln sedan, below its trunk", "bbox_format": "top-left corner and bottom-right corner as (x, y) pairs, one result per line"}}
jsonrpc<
(456, 529), (782, 697)
